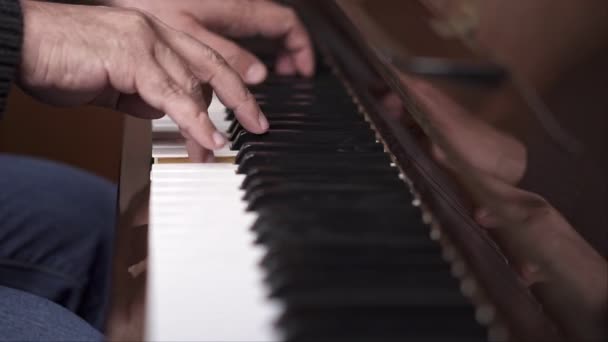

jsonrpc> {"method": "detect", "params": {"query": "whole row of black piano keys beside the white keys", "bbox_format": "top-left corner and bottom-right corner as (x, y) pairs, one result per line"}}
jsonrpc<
(218, 38), (486, 342)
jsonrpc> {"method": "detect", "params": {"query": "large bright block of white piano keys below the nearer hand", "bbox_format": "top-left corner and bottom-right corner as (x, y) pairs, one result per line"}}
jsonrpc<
(146, 164), (280, 342)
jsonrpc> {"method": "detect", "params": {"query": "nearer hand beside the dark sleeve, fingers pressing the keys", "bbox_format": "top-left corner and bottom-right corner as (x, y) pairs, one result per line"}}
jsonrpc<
(19, 0), (268, 161)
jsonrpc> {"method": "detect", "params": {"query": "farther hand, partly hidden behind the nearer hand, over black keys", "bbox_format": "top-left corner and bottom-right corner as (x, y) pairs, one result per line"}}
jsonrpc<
(105, 0), (315, 84)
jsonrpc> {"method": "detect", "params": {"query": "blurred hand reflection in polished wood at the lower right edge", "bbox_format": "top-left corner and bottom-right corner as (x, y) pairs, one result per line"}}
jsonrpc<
(476, 186), (608, 341)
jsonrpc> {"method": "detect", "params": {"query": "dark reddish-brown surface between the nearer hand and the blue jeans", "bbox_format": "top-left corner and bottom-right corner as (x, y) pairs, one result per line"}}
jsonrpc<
(0, 87), (123, 182)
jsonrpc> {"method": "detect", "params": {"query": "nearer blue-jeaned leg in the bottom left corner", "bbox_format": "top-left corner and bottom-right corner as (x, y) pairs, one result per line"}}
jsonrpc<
(0, 286), (104, 342)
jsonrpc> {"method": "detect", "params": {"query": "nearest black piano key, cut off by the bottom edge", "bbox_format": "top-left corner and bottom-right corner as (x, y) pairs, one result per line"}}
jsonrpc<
(278, 306), (487, 342)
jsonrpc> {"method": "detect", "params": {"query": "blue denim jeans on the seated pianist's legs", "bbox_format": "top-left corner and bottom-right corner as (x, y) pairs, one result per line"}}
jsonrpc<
(0, 155), (116, 341)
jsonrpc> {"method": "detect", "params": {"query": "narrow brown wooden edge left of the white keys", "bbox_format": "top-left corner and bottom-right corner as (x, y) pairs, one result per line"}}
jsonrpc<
(105, 115), (152, 341)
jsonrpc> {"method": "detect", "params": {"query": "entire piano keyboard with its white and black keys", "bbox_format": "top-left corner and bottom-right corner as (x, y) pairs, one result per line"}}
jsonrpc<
(147, 54), (486, 342)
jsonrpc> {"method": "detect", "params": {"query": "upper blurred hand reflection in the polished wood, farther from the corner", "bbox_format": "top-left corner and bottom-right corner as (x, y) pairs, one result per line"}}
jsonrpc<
(384, 74), (526, 185)
